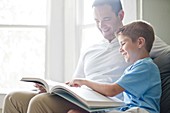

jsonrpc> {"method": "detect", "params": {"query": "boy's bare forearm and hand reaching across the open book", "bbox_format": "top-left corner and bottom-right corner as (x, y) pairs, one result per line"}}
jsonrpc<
(72, 78), (124, 97)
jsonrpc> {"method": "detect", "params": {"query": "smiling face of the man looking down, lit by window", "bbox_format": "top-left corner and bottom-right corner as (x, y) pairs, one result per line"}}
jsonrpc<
(94, 5), (122, 41)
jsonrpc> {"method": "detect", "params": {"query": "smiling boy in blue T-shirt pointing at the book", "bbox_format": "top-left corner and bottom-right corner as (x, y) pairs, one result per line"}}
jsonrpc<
(68, 21), (161, 113)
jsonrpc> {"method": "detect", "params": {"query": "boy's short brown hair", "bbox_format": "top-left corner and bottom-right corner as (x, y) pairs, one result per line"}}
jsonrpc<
(116, 21), (155, 52)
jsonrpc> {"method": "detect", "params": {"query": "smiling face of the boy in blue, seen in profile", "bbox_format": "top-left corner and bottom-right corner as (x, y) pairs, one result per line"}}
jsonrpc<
(118, 35), (139, 63)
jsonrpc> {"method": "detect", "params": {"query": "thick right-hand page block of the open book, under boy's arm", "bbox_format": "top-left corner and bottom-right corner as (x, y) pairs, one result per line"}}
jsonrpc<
(51, 84), (123, 108)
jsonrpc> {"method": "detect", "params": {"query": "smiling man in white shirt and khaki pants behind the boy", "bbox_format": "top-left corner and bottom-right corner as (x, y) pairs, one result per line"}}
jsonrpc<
(3, 0), (167, 113)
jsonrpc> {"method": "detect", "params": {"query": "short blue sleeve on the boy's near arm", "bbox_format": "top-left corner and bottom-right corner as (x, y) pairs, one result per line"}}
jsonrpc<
(116, 63), (150, 97)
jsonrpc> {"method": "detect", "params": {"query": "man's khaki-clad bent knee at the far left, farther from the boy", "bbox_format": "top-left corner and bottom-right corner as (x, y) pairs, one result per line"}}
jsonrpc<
(2, 92), (36, 113)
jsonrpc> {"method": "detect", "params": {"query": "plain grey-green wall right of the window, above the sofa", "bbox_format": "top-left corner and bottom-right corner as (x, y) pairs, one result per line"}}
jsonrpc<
(143, 0), (170, 44)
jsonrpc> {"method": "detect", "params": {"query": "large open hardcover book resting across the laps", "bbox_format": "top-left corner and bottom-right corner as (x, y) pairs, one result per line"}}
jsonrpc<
(21, 77), (124, 112)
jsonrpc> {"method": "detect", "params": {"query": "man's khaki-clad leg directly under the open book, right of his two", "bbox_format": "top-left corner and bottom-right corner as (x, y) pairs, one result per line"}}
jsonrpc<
(27, 93), (88, 113)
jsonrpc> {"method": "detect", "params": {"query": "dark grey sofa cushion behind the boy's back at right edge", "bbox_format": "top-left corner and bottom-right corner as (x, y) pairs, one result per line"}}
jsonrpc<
(153, 48), (170, 113)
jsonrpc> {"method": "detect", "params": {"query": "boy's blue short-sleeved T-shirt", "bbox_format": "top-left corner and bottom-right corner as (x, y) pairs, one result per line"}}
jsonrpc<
(116, 58), (162, 113)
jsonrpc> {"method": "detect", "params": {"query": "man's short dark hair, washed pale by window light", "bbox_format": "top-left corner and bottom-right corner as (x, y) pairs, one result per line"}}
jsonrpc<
(92, 0), (122, 16)
